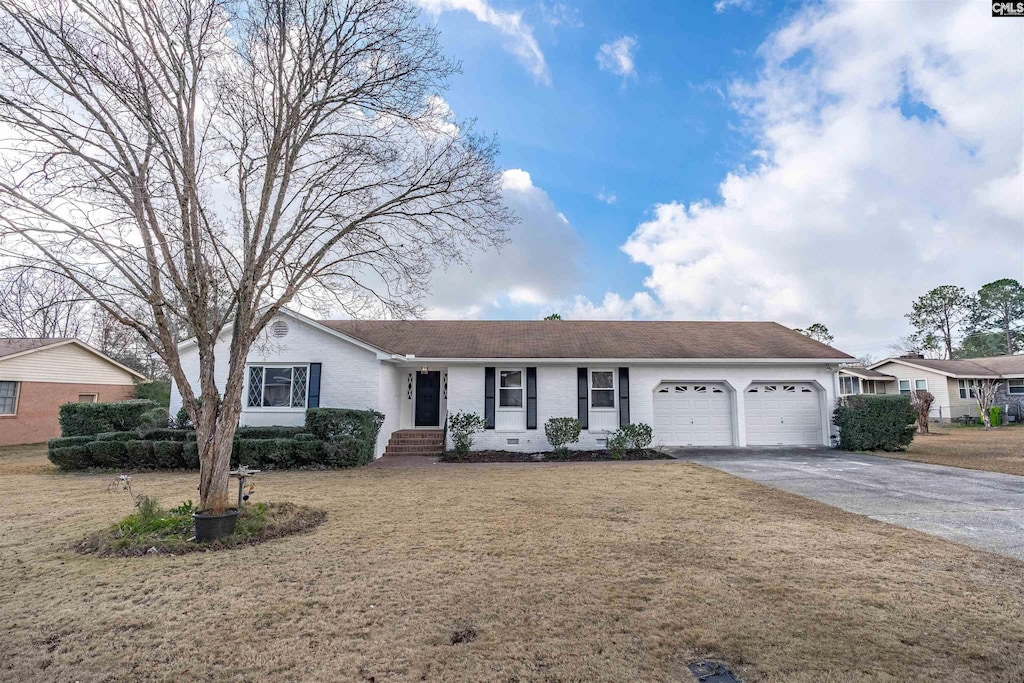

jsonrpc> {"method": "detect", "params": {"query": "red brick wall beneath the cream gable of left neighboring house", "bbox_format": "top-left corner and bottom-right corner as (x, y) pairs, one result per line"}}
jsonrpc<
(0, 382), (135, 445)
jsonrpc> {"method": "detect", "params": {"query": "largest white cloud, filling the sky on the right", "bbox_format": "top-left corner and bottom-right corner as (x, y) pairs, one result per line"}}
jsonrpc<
(602, 3), (1024, 353)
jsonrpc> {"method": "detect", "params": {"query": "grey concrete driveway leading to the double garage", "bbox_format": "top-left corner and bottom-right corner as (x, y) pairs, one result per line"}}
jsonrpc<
(673, 449), (1024, 559)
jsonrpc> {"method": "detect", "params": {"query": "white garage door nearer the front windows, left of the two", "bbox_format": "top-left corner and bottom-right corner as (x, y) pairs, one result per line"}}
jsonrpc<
(654, 382), (732, 445)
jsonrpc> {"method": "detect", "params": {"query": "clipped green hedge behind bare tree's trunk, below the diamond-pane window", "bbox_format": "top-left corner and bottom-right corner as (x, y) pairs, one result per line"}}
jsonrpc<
(48, 409), (383, 470)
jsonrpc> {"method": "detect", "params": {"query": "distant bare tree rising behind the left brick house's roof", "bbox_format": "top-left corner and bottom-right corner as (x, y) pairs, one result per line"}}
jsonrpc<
(0, 266), (92, 339)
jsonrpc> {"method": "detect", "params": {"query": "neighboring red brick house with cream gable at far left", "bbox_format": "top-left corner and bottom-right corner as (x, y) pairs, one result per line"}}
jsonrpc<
(0, 339), (145, 445)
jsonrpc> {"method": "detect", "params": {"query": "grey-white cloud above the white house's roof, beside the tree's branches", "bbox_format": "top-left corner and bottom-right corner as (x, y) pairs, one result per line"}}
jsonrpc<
(427, 169), (584, 318)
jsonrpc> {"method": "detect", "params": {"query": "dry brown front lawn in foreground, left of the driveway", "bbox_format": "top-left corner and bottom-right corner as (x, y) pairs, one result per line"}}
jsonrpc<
(0, 451), (1024, 683)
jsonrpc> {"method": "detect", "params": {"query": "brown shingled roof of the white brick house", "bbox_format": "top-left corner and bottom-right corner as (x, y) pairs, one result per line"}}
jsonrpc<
(321, 321), (851, 359)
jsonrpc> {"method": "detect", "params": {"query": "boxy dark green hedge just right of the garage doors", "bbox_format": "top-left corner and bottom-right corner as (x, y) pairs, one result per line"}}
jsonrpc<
(833, 394), (916, 451)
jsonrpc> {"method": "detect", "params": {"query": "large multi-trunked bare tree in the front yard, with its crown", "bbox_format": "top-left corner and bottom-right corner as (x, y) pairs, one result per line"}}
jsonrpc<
(0, 0), (514, 511)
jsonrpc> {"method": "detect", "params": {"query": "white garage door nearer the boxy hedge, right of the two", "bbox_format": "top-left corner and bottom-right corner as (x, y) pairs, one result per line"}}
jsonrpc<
(743, 382), (822, 445)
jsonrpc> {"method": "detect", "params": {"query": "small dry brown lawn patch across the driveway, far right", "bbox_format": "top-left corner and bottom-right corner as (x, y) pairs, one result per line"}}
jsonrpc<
(877, 426), (1024, 475)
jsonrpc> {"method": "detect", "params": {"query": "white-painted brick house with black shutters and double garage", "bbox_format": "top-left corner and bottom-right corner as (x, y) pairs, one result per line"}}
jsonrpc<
(170, 311), (852, 455)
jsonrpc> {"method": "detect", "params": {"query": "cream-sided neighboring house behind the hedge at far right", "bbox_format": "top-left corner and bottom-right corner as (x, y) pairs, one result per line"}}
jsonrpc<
(840, 354), (1024, 421)
